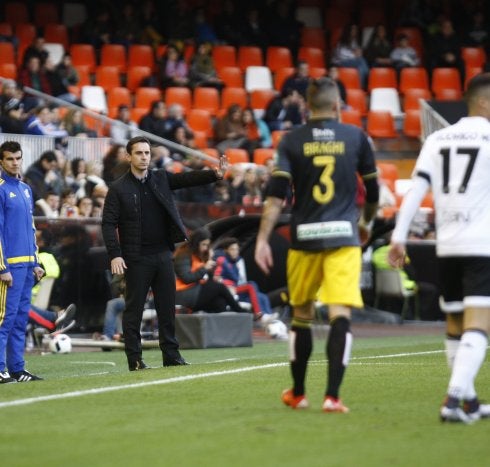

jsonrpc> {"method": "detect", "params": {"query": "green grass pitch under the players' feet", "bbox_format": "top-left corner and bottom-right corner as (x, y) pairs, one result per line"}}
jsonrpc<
(0, 335), (490, 467)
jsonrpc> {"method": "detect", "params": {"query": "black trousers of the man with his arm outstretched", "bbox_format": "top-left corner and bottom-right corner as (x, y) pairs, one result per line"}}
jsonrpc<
(122, 251), (179, 362)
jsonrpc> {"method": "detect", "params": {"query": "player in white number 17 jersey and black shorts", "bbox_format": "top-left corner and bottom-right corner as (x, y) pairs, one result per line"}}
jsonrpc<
(389, 73), (490, 423)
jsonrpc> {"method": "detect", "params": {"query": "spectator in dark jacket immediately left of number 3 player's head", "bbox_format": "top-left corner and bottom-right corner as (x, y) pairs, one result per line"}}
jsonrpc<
(263, 89), (304, 131)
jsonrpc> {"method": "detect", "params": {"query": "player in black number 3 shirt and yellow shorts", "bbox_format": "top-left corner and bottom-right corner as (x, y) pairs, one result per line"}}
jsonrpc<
(255, 78), (378, 413)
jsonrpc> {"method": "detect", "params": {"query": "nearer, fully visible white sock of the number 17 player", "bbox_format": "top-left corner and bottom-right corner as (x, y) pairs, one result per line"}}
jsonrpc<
(447, 331), (488, 399)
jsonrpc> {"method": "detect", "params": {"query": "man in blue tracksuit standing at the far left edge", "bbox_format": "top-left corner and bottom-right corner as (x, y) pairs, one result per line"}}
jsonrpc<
(0, 141), (44, 384)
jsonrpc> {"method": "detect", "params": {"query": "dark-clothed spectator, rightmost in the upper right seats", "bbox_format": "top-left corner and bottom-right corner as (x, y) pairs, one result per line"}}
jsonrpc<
(429, 19), (464, 79)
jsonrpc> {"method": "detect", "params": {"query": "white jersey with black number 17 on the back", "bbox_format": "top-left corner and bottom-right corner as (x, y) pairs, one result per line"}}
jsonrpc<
(414, 117), (490, 256)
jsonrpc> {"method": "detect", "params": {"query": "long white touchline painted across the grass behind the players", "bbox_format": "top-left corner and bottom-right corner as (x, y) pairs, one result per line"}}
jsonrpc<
(0, 350), (444, 409)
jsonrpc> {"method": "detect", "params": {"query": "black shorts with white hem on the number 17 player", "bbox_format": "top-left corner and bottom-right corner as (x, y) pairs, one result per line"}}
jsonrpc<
(437, 256), (490, 313)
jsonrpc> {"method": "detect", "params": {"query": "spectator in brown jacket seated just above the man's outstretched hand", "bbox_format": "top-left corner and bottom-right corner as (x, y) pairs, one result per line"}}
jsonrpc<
(214, 104), (248, 154)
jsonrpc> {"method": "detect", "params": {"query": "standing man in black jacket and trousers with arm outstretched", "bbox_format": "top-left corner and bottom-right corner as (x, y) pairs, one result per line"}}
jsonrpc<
(102, 136), (227, 371)
